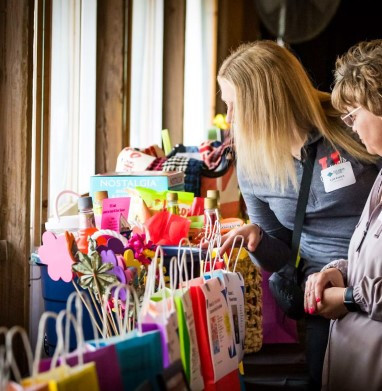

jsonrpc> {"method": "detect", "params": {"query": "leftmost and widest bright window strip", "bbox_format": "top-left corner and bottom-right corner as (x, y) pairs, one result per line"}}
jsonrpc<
(48, 0), (97, 215)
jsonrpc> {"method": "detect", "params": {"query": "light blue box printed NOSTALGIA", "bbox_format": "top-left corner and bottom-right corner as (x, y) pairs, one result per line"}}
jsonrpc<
(90, 171), (184, 198)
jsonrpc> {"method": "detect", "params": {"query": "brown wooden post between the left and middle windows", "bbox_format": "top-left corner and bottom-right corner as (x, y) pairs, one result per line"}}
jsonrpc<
(96, 0), (131, 173)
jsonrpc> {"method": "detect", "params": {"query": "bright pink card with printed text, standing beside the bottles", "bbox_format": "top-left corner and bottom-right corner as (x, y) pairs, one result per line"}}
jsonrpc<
(101, 197), (130, 232)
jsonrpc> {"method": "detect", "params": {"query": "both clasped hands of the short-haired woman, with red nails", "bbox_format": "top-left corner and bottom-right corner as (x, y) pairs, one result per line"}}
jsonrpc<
(304, 268), (348, 319)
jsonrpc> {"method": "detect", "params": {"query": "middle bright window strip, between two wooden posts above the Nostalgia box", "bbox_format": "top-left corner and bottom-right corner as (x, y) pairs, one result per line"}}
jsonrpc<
(130, 0), (163, 148)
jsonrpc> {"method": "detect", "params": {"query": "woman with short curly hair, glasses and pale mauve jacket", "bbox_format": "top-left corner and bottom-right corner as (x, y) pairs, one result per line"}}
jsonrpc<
(305, 39), (382, 391)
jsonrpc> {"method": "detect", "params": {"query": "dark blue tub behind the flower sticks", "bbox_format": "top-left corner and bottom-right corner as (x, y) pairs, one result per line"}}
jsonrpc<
(32, 254), (102, 356)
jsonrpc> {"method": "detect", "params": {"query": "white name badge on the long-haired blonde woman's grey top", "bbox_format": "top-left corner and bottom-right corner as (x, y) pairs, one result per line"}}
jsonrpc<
(321, 162), (356, 193)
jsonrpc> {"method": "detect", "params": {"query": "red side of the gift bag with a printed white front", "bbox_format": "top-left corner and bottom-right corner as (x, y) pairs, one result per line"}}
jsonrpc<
(190, 286), (240, 391)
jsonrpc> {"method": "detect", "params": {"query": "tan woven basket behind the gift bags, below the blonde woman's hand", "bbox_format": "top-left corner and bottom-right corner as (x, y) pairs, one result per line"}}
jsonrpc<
(232, 249), (263, 353)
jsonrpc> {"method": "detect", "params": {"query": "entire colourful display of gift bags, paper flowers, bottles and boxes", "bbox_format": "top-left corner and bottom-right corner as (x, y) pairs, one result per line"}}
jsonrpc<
(0, 139), (262, 391)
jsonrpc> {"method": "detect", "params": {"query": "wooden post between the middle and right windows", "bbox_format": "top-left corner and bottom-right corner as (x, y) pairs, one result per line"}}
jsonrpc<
(162, 0), (186, 145)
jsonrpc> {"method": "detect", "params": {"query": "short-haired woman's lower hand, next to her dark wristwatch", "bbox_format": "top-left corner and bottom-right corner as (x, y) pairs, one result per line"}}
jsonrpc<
(317, 287), (348, 319)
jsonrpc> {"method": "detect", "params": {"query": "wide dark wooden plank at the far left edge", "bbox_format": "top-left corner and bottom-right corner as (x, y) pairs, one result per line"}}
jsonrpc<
(0, 0), (34, 336)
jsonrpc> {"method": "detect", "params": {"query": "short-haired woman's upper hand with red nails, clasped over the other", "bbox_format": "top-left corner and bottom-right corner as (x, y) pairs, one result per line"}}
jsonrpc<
(304, 268), (345, 314)
